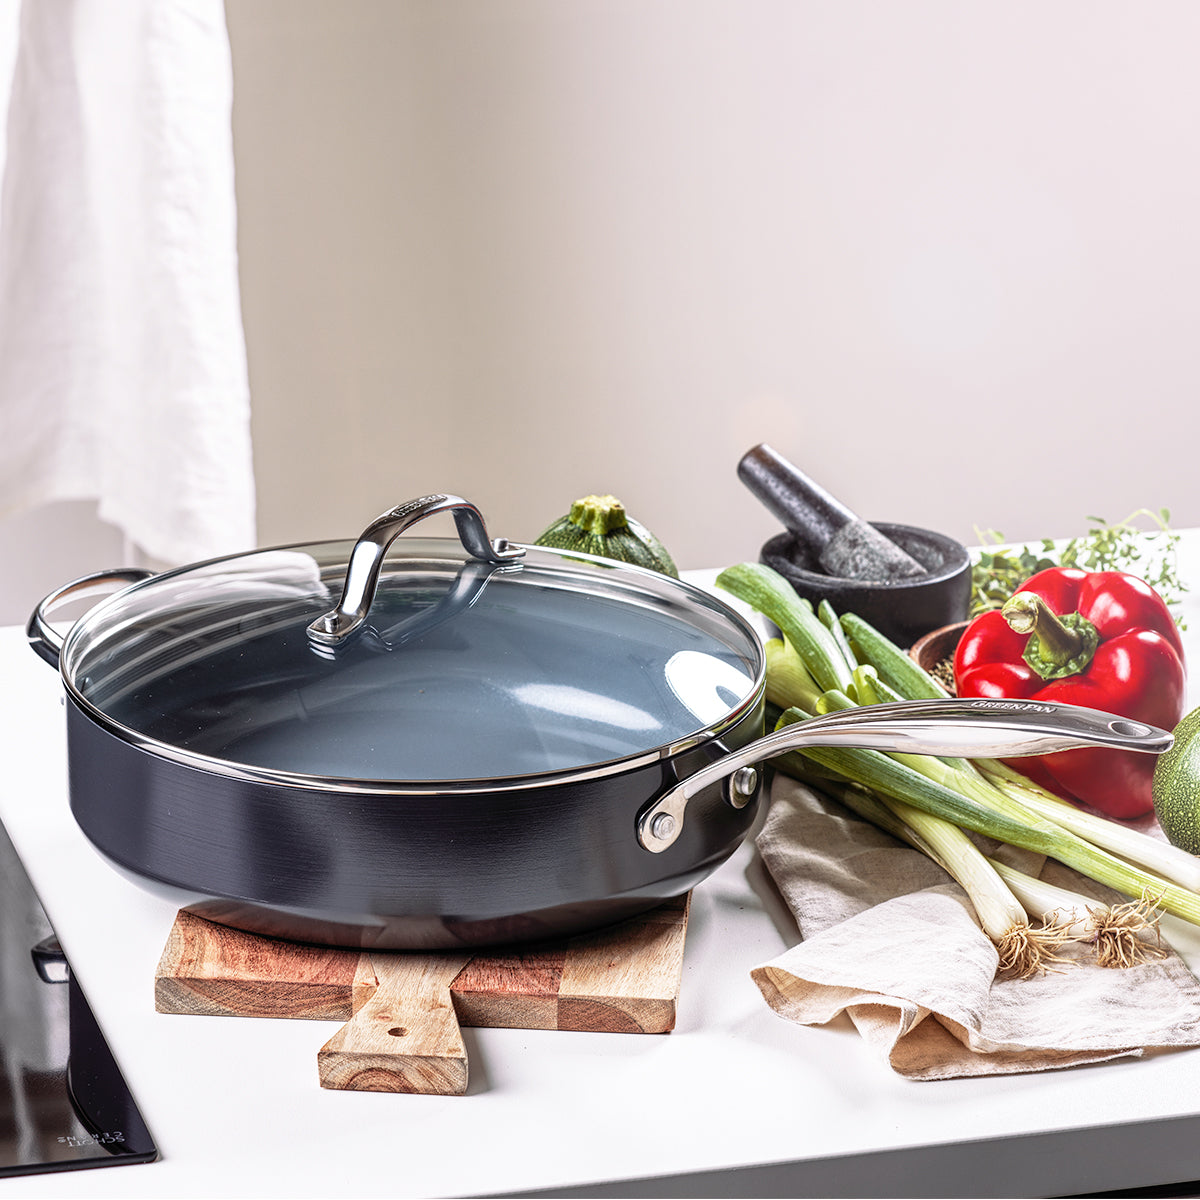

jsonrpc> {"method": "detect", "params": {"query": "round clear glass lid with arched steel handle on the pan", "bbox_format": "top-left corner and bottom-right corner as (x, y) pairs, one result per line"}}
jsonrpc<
(62, 497), (761, 784)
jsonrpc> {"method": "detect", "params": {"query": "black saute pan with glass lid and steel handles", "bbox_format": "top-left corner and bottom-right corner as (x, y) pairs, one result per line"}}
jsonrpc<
(29, 494), (1171, 949)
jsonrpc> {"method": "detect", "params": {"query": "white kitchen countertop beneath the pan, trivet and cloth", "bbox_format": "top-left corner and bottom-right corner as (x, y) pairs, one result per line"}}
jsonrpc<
(7, 554), (1200, 1200)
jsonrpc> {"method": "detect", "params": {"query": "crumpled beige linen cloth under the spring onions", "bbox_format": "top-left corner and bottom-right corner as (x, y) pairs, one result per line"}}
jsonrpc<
(752, 775), (1200, 1080)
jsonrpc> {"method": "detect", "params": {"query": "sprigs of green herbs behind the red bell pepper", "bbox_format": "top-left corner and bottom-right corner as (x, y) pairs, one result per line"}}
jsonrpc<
(970, 509), (1187, 628)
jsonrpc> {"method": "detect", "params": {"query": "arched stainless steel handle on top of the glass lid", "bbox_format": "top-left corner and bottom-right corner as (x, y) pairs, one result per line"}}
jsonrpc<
(308, 493), (524, 647)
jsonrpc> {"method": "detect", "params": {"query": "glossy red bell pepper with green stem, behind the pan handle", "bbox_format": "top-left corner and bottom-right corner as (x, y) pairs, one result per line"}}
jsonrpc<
(954, 568), (1186, 820)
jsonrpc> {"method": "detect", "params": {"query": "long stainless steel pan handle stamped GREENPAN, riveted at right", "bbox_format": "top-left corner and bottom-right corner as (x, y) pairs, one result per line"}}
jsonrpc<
(637, 700), (1172, 853)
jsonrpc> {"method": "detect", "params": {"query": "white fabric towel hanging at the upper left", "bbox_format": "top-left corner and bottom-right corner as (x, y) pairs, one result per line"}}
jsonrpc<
(0, 0), (254, 563)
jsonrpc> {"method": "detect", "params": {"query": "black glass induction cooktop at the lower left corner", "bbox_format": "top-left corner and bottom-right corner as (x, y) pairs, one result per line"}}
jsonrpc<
(0, 824), (158, 1176)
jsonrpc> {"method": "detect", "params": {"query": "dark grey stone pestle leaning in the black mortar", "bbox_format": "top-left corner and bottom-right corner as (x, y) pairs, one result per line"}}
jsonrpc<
(738, 443), (926, 582)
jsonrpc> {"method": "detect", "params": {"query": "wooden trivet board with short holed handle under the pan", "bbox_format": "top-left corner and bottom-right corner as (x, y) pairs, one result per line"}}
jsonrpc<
(155, 894), (690, 1096)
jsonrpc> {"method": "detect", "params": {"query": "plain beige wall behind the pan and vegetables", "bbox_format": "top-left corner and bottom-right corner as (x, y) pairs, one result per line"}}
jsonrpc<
(7, 0), (1200, 620)
